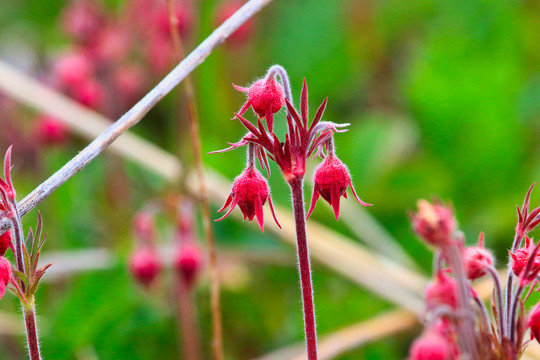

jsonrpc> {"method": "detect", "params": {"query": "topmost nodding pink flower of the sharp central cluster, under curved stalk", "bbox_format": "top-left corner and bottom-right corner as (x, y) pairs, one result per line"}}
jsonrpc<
(233, 76), (285, 131)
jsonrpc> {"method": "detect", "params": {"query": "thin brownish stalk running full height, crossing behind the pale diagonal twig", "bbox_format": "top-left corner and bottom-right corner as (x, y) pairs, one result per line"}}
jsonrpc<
(167, 0), (224, 360)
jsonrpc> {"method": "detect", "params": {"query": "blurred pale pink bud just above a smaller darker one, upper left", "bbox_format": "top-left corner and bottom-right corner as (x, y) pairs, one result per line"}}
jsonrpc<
(54, 52), (94, 88)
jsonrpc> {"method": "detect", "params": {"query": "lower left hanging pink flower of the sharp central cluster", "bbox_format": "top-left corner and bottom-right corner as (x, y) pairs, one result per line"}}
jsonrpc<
(216, 166), (281, 231)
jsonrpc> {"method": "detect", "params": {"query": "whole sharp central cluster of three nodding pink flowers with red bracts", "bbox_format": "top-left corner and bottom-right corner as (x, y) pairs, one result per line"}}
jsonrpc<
(215, 65), (370, 231)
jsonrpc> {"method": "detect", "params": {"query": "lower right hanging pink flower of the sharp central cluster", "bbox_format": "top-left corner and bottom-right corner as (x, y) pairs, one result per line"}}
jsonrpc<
(307, 155), (371, 220)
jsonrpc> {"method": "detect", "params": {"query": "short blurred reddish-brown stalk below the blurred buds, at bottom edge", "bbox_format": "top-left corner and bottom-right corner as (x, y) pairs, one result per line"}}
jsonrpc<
(175, 278), (202, 360)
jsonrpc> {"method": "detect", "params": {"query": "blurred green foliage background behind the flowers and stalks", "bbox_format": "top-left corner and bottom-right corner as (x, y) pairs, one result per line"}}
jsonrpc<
(0, 0), (540, 360)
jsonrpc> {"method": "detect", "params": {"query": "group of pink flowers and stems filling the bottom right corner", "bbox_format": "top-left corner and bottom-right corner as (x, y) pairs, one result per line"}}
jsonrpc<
(410, 185), (540, 360)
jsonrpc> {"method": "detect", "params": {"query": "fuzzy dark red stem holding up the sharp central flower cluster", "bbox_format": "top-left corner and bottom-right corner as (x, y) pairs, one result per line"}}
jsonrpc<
(289, 177), (317, 360)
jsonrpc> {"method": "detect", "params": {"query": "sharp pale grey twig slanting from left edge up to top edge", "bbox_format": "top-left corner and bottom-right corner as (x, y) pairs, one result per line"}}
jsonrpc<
(0, 0), (272, 230)
